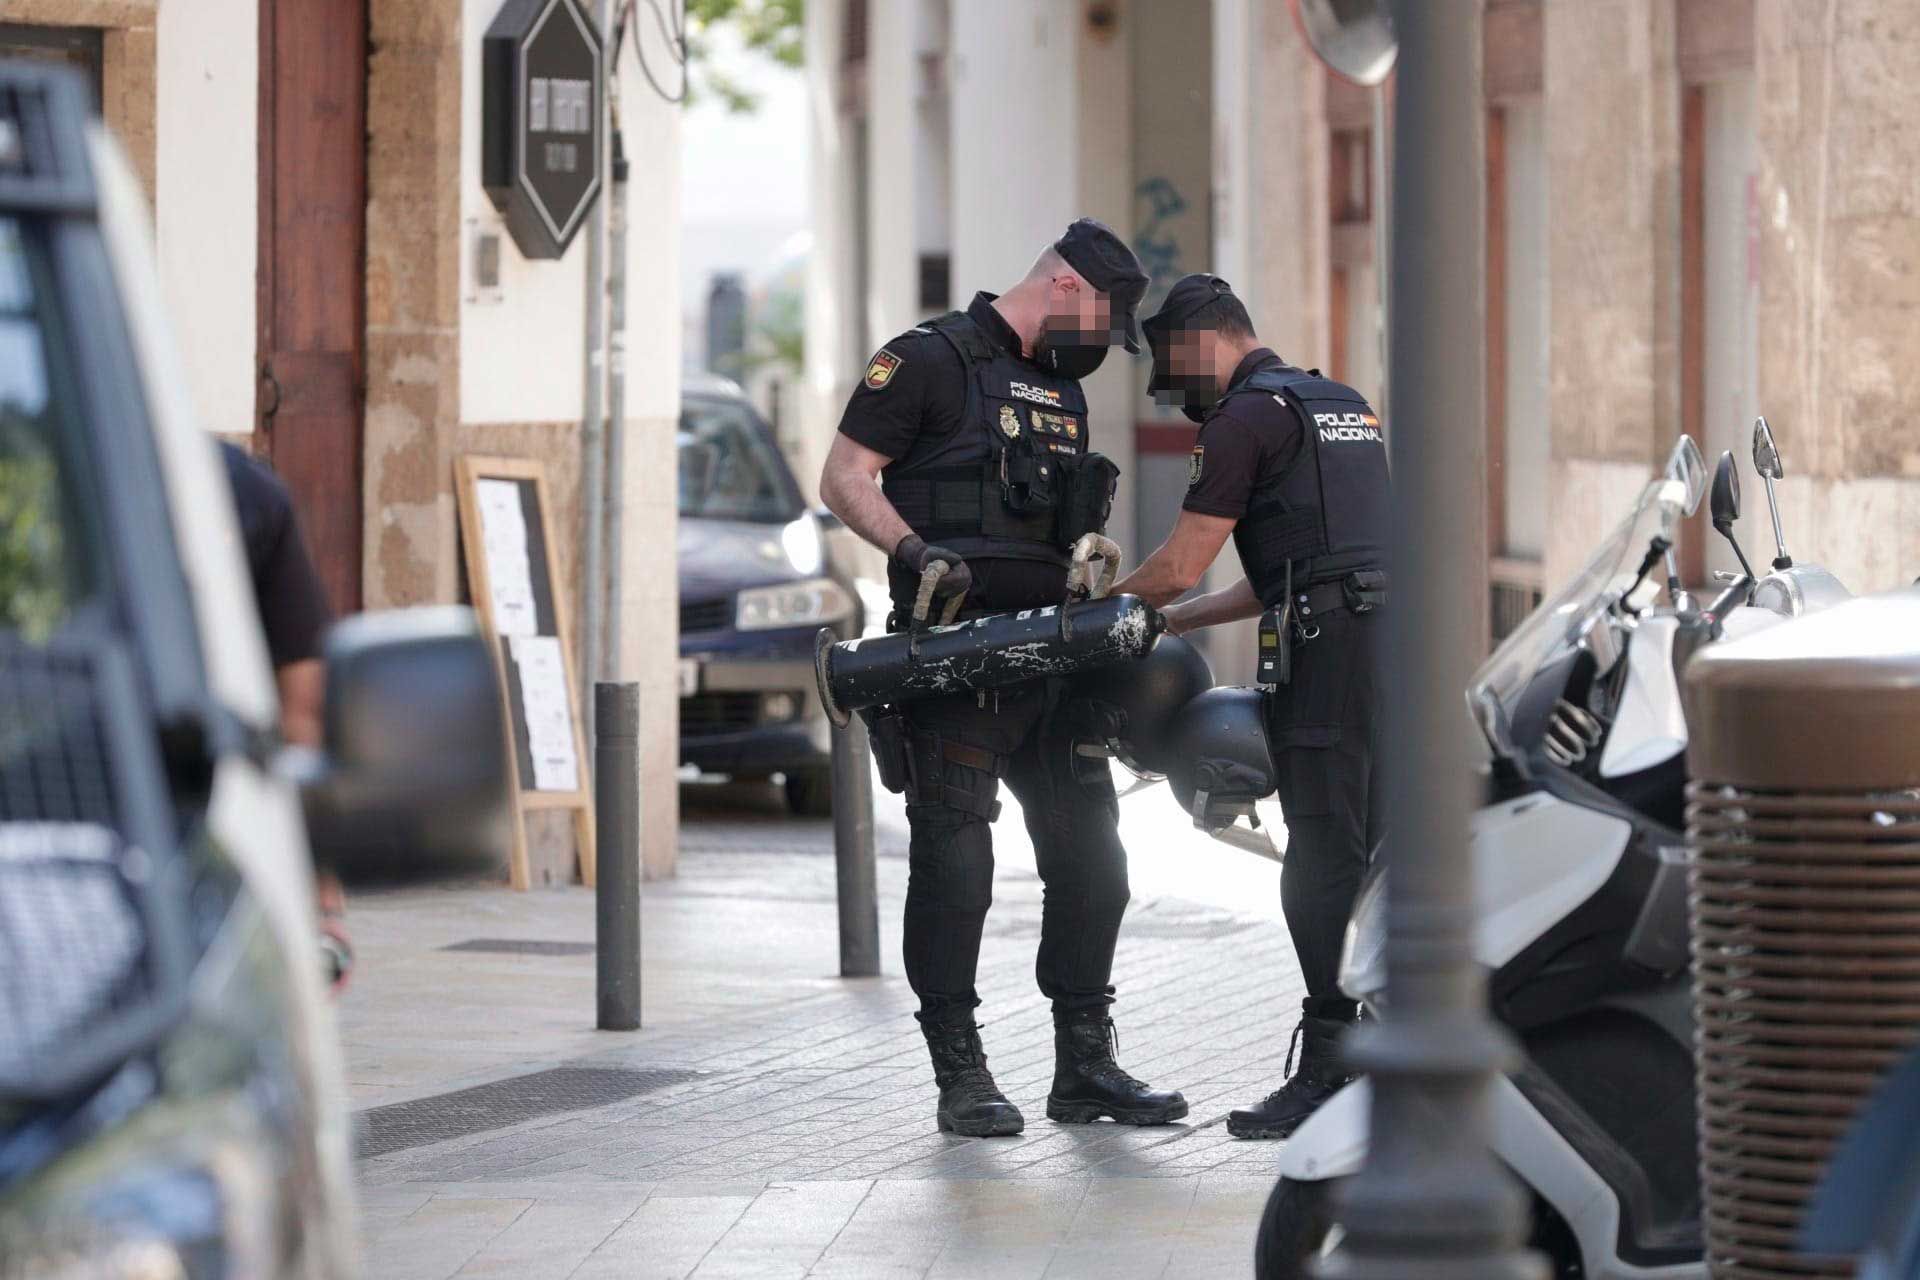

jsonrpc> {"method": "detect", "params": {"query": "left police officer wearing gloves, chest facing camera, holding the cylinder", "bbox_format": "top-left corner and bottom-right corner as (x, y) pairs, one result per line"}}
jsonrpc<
(820, 219), (1187, 1136)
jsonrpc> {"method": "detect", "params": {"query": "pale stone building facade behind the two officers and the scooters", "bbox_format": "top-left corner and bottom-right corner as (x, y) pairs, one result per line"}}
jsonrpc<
(806, 0), (1920, 679)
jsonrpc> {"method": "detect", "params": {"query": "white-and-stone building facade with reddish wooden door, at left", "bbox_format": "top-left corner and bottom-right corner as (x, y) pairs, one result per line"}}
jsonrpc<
(0, 0), (680, 885)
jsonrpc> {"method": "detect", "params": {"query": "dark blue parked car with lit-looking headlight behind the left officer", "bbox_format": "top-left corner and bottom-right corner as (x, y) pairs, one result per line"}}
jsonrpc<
(678, 378), (858, 816)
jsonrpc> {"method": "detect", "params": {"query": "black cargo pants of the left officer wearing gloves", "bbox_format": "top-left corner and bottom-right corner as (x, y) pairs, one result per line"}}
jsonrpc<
(902, 679), (1127, 1021)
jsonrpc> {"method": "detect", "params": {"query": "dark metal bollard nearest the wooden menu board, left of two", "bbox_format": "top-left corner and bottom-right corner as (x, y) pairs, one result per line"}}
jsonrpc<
(593, 681), (639, 1031)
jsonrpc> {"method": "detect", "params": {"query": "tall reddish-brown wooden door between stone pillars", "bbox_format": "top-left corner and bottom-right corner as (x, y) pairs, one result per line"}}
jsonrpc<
(257, 0), (367, 612)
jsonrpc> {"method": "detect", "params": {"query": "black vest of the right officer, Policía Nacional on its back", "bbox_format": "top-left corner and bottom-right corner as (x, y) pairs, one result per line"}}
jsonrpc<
(1221, 360), (1392, 606)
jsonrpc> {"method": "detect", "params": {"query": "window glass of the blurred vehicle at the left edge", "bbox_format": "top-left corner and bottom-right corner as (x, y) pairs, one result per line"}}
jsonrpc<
(0, 217), (88, 645)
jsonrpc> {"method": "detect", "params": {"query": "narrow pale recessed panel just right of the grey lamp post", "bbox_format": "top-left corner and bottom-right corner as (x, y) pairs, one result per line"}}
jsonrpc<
(1492, 102), (1553, 558)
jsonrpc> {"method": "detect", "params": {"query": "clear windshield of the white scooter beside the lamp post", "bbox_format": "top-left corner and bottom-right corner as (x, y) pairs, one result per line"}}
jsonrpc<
(1467, 478), (1688, 756)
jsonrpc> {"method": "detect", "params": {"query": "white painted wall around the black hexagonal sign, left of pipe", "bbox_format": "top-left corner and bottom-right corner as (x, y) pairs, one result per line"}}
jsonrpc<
(460, 0), (587, 422)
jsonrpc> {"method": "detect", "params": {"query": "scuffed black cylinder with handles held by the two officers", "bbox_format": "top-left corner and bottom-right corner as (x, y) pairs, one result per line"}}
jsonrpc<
(814, 595), (1167, 725)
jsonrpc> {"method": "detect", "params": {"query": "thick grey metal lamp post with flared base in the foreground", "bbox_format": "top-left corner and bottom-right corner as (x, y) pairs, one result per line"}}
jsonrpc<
(1313, 0), (1548, 1280)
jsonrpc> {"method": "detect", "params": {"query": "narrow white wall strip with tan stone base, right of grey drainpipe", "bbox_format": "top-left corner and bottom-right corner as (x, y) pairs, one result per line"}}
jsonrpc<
(618, 21), (682, 879)
